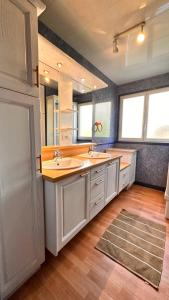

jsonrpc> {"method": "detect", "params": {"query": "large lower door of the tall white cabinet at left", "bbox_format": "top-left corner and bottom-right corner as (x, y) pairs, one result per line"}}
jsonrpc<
(0, 89), (44, 299)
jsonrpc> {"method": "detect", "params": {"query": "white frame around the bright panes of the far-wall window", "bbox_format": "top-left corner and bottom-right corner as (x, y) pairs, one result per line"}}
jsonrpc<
(118, 87), (169, 144)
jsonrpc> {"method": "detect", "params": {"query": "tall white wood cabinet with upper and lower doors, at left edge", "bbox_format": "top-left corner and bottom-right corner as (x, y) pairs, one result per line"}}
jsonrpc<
(0, 0), (45, 300)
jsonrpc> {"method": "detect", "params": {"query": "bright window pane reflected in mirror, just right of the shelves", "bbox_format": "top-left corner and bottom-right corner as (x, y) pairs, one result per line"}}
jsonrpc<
(78, 103), (93, 139)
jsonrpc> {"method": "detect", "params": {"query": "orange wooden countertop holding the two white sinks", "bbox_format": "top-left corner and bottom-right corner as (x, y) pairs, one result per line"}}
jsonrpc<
(42, 155), (121, 182)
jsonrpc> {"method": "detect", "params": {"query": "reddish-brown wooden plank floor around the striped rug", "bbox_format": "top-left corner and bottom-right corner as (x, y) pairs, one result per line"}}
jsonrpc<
(11, 185), (169, 300)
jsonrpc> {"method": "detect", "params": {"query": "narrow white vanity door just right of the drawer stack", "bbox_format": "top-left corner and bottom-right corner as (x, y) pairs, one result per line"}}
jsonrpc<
(105, 160), (119, 205)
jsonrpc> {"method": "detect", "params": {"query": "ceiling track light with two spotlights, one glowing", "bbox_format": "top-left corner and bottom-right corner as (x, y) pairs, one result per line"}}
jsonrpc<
(113, 22), (146, 53)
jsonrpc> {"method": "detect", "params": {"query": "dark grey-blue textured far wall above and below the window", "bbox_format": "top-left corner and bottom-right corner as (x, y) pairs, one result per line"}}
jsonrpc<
(115, 73), (169, 188)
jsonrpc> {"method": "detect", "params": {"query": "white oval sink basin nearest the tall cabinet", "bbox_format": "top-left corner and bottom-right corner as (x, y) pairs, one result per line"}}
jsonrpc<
(42, 157), (83, 170)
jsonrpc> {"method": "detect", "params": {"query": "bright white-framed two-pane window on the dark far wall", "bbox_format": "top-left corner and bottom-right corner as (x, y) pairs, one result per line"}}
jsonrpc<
(119, 88), (169, 142)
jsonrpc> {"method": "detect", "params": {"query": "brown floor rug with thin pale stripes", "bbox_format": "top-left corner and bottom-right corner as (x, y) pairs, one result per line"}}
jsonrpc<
(96, 209), (166, 289)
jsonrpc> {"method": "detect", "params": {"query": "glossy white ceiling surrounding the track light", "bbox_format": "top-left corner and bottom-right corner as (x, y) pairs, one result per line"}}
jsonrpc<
(40, 0), (169, 84)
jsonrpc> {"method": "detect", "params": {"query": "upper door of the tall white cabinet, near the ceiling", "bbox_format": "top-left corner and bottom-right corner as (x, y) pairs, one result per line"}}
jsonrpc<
(0, 0), (39, 97)
